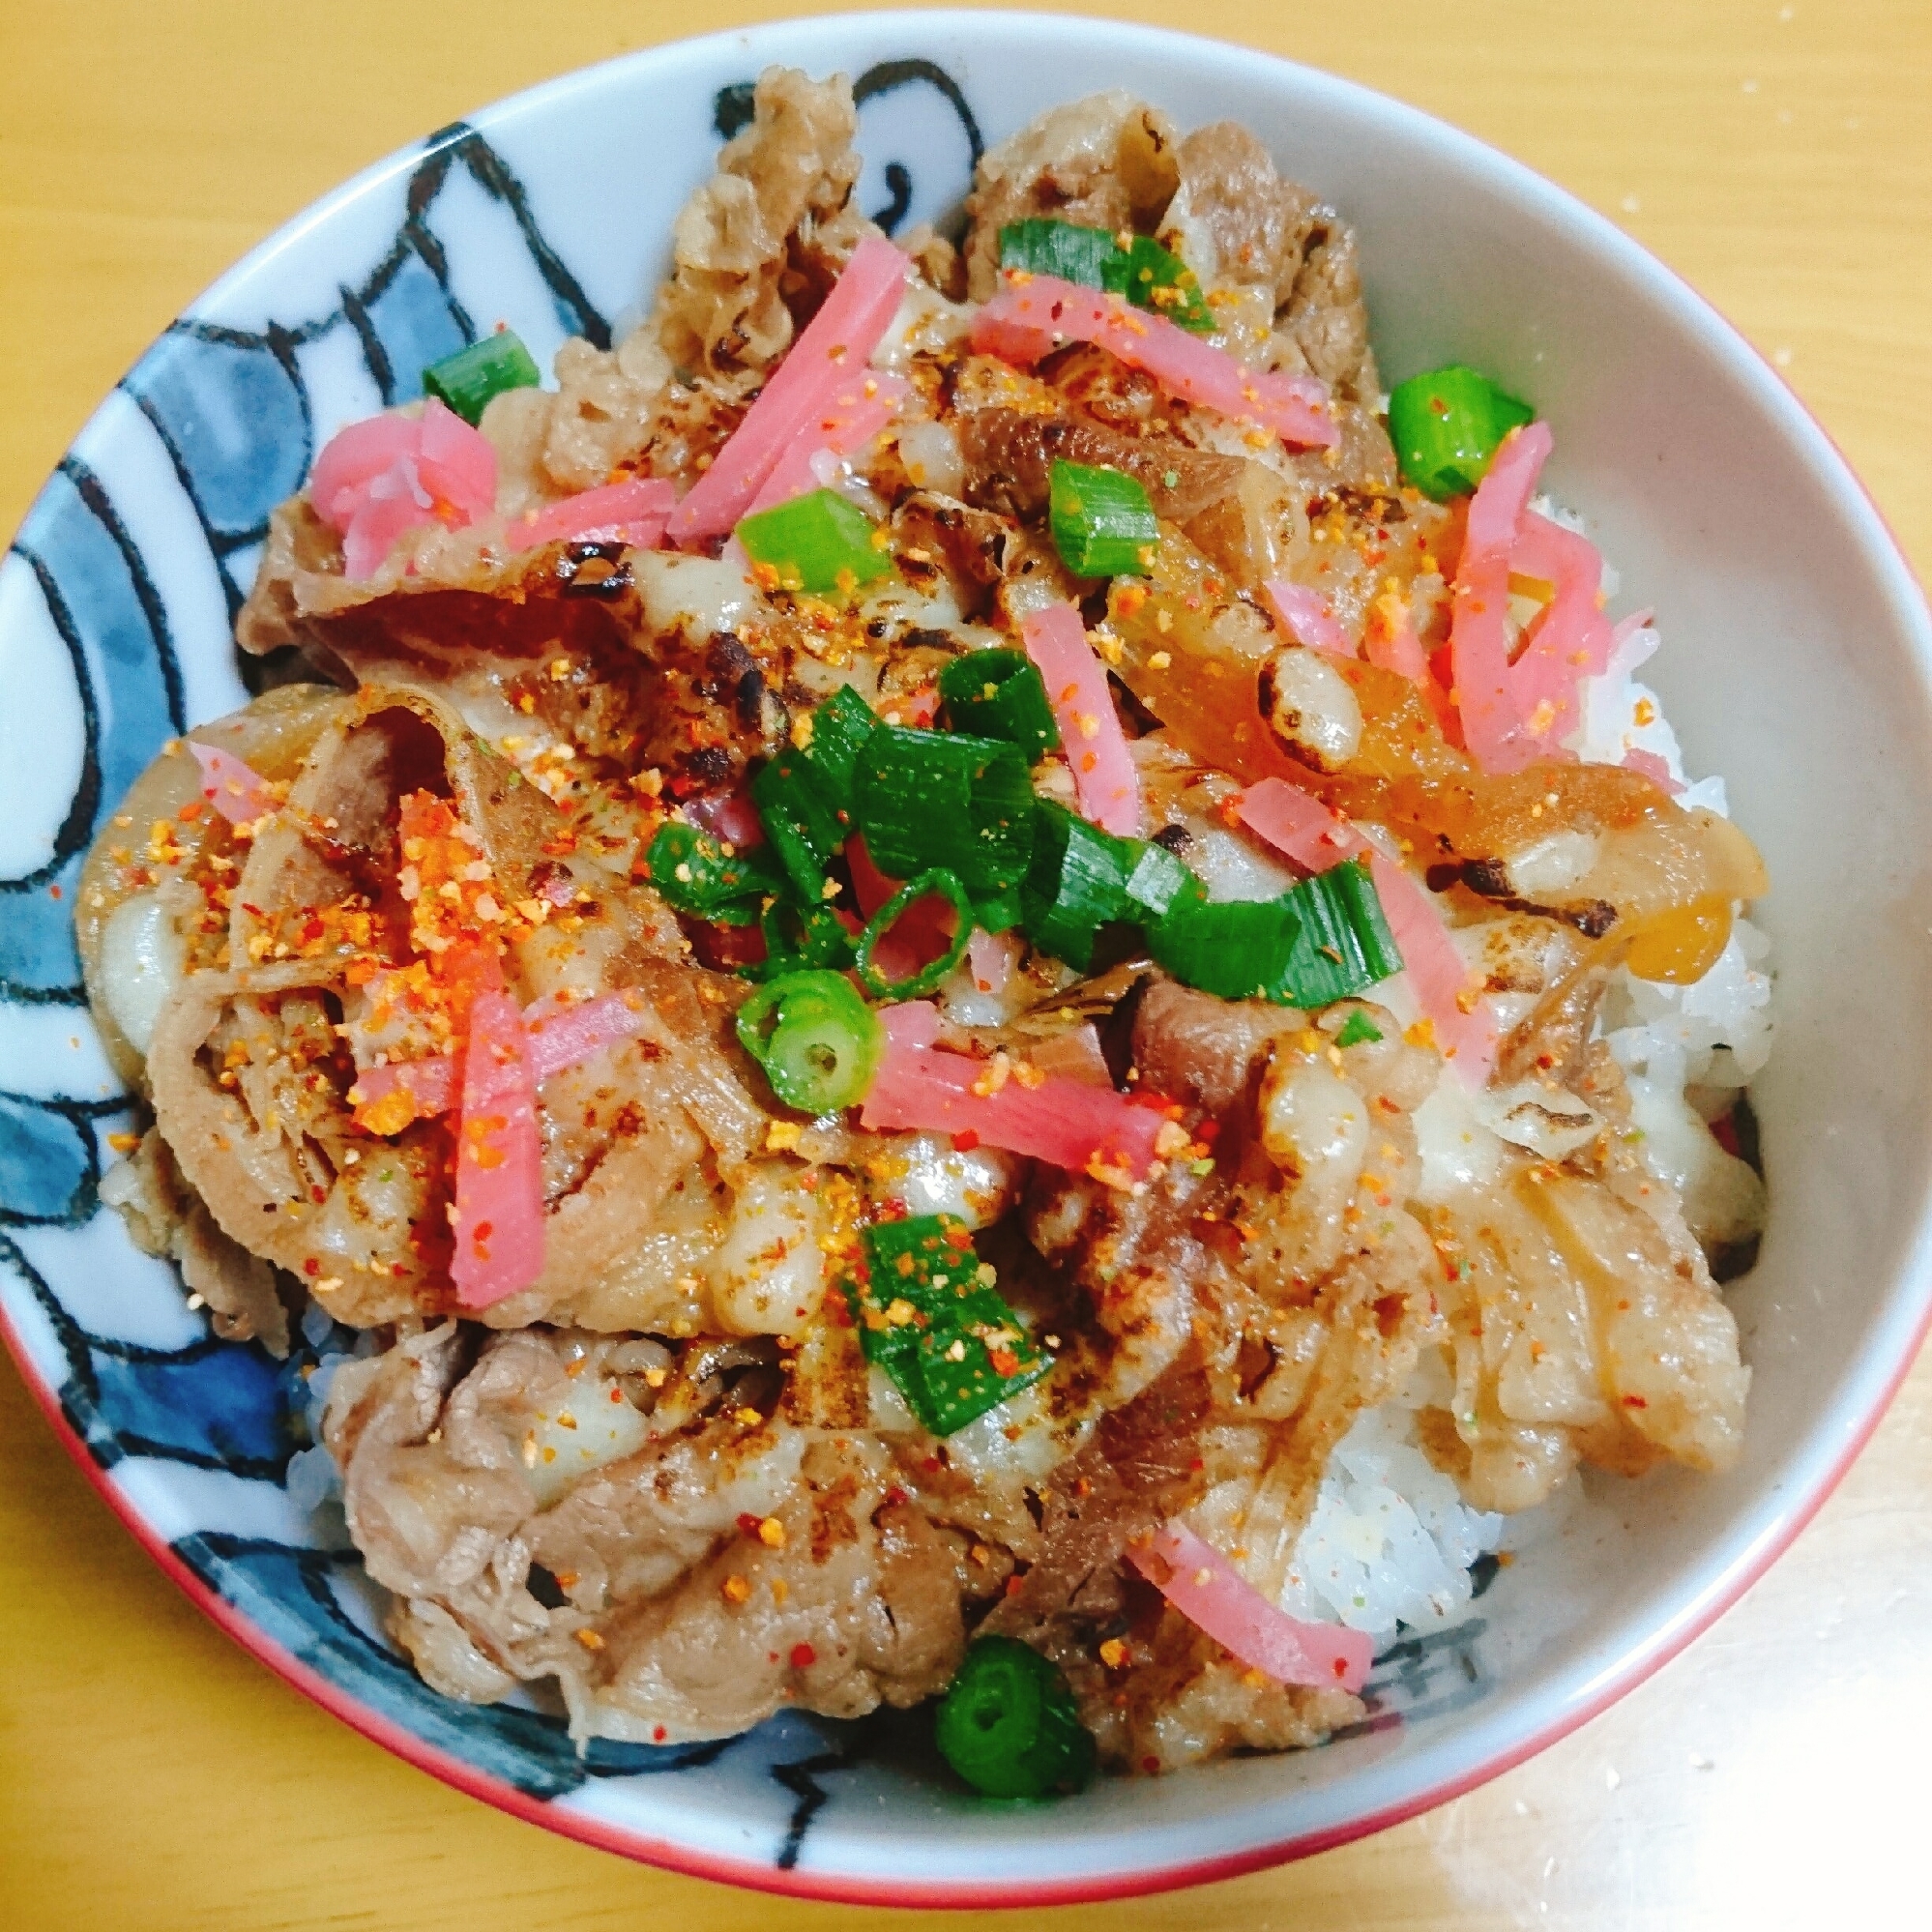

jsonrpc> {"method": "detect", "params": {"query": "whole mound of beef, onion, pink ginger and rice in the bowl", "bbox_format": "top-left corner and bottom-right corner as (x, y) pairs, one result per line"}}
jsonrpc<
(79, 70), (1770, 1799)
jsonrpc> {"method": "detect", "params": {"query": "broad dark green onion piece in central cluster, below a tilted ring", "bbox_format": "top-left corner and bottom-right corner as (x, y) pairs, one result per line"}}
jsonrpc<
(854, 724), (1034, 898)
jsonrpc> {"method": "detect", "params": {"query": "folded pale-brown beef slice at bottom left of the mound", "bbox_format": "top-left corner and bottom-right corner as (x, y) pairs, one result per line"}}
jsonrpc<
(325, 1328), (991, 1742)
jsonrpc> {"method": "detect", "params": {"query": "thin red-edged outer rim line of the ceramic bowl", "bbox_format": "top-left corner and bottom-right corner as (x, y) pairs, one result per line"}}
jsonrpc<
(0, 12), (1932, 1909)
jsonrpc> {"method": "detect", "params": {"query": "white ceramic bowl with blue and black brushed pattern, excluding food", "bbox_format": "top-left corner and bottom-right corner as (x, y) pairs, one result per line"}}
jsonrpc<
(0, 14), (1932, 1905)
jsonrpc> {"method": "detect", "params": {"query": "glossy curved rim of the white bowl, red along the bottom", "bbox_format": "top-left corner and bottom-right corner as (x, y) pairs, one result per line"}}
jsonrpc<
(11, 8), (1932, 1909)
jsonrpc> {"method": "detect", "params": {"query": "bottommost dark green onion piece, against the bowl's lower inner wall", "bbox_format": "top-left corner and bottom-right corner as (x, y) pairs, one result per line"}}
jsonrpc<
(933, 1636), (1096, 1799)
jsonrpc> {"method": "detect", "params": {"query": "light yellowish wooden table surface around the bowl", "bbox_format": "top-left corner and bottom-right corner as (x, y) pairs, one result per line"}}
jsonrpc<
(0, 0), (1932, 1932)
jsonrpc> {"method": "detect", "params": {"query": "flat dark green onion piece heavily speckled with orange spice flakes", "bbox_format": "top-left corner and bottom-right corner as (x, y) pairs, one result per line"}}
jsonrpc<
(844, 1215), (1053, 1436)
